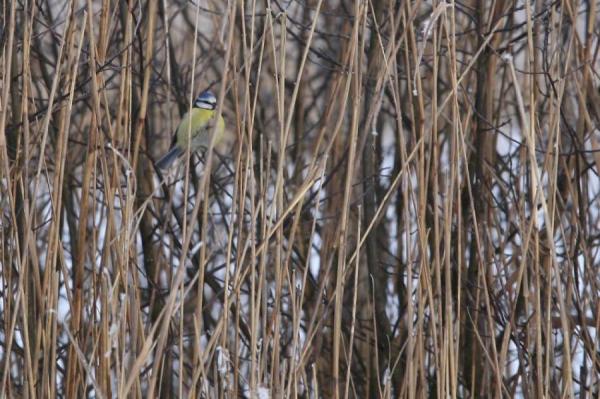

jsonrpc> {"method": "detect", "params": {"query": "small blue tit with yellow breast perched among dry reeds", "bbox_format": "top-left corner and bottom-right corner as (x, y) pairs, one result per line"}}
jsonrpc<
(156, 90), (225, 169)
